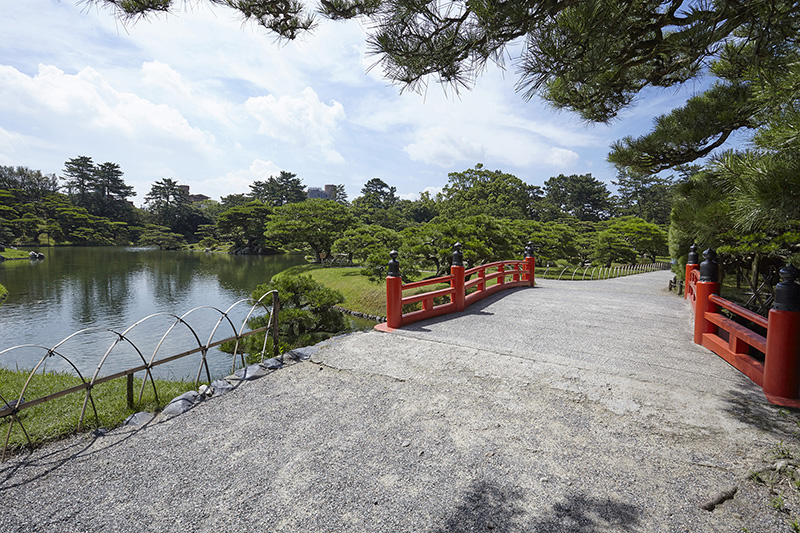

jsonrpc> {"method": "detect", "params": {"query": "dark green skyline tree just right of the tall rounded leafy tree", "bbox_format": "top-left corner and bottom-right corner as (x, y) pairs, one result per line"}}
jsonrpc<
(544, 174), (611, 221)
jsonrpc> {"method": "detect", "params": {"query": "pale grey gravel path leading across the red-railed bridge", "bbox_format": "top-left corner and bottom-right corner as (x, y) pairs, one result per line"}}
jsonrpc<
(0, 272), (800, 533)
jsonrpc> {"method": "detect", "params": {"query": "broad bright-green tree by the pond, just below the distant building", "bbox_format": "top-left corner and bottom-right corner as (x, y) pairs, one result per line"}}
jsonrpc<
(264, 199), (355, 263)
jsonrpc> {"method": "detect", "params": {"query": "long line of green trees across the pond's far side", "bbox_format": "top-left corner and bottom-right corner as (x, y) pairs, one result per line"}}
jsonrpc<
(0, 156), (676, 277)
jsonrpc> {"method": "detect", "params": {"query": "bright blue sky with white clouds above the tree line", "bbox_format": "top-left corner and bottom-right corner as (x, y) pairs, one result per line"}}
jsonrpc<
(0, 0), (724, 206)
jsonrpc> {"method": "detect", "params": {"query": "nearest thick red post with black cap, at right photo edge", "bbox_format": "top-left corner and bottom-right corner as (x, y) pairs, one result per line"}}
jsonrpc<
(763, 263), (800, 398)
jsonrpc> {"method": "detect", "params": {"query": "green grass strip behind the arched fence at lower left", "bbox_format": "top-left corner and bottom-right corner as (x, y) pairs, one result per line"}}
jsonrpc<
(0, 368), (195, 452)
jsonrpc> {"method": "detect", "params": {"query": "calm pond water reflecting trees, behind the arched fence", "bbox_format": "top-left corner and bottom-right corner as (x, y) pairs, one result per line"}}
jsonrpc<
(0, 247), (304, 379)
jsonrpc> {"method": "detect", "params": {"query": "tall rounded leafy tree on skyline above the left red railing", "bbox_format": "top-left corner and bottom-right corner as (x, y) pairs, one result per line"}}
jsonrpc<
(437, 163), (530, 219)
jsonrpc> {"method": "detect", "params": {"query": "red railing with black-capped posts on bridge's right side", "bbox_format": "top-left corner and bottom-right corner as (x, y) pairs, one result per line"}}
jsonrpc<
(685, 247), (800, 408)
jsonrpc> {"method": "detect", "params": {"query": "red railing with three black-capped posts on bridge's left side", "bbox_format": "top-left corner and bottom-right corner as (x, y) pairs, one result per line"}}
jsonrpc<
(376, 243), (536, 331)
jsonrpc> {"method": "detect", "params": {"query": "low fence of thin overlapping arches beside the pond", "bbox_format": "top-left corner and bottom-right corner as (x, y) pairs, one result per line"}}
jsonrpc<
(0, 291), (283, 460)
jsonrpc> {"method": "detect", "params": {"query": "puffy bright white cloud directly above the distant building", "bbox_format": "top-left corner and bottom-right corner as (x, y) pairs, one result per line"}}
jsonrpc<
(245, 87), (345, 163)
